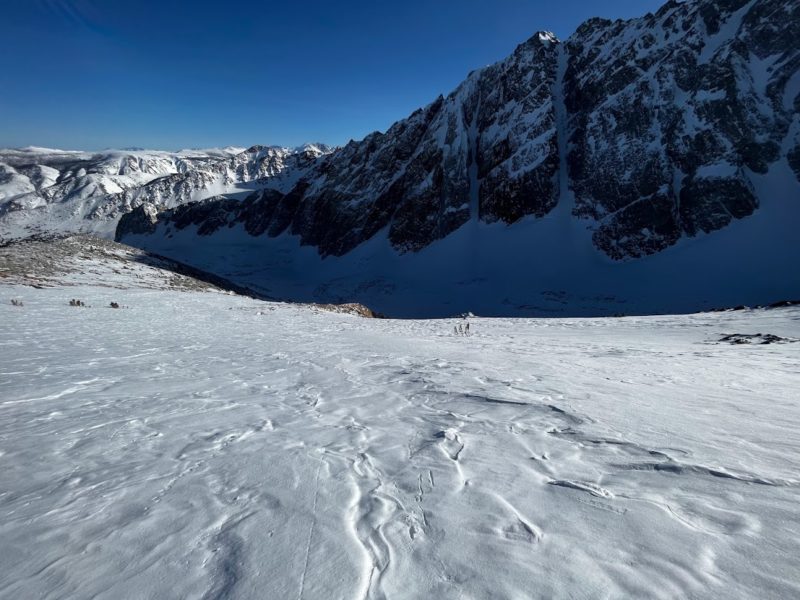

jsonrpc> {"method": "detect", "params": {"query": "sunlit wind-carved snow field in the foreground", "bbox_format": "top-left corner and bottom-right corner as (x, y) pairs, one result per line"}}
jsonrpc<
(0, 283), (800, 599)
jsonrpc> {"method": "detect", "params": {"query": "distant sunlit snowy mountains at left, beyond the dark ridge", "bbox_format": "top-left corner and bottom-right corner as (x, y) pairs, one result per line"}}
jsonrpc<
(0, 144), (332, 240)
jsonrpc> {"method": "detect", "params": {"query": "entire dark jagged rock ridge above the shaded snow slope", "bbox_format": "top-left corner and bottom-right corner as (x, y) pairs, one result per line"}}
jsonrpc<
(117, 0), (800, 259)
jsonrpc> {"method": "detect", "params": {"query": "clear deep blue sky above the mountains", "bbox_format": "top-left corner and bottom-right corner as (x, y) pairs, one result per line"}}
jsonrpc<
(0, 0), (662, 150)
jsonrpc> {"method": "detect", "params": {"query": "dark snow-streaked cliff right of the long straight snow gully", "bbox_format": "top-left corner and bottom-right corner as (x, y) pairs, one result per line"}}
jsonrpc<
(565, 0), (800, 258)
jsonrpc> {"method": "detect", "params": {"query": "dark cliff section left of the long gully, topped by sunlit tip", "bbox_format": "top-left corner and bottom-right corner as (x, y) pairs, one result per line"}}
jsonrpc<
(201, 34), (558, 255)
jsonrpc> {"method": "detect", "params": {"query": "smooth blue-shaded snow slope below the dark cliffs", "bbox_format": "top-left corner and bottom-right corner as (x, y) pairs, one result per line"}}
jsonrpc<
(120, 155), (800, 317)
